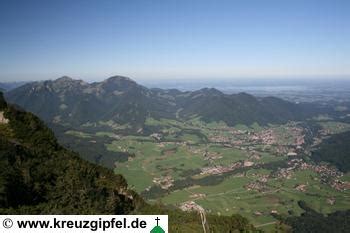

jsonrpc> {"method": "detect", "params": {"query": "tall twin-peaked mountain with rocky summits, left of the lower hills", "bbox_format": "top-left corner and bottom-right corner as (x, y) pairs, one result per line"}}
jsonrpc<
(7, 76), (178, 129)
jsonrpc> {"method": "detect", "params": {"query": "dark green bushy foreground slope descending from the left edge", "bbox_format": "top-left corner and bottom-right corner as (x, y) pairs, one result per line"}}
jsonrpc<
(0, 93), (255, 232)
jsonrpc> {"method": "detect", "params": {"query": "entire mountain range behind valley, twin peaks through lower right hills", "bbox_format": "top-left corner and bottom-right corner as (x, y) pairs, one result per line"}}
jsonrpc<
(6, 76), (315, 129)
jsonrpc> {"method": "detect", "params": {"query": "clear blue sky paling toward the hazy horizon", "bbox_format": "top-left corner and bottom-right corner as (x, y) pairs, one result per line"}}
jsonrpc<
(0, 0), (350, 82)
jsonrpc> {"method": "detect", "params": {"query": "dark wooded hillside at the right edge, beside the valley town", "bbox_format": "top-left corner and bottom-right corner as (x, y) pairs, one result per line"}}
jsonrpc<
(311, 132), (350, 172)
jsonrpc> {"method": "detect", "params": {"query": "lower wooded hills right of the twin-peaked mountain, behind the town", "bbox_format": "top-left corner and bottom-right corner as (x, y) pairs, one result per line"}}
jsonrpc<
(181, 89), (308, 126)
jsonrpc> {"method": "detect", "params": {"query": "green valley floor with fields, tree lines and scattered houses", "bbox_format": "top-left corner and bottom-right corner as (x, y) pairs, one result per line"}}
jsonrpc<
(60, 118), (350, 230)
